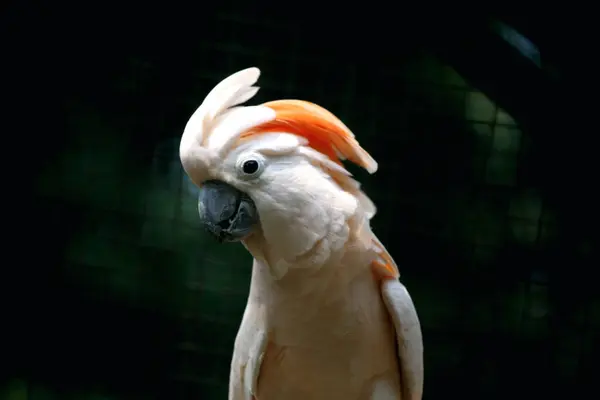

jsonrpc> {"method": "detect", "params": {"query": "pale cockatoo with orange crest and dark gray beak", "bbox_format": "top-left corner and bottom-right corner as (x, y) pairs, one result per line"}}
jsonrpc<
(179, 68), (423, 400)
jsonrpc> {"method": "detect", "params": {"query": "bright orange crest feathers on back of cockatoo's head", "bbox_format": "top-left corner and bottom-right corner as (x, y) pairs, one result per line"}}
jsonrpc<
(241, 100), (377, 172)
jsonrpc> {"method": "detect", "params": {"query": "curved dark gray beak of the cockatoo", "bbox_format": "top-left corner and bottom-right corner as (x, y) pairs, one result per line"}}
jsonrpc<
(198, 180), (258, 242)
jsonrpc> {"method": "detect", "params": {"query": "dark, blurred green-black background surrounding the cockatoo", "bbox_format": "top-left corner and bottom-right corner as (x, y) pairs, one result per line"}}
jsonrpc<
(0, 2), (600, 400)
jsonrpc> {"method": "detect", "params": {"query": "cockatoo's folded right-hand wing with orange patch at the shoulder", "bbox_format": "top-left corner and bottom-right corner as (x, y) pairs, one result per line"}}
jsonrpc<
(373, 238), (423, 400)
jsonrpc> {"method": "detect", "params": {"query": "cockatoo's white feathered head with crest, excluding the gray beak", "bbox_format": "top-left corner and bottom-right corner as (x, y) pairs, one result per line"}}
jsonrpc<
(179, 68), (377, 272)
